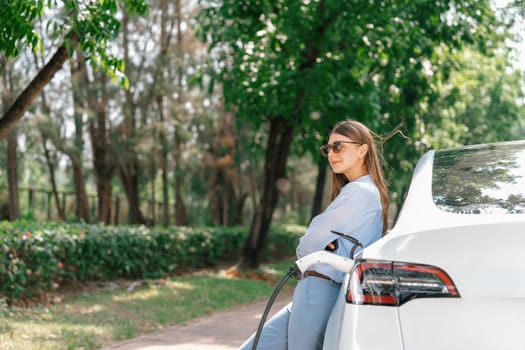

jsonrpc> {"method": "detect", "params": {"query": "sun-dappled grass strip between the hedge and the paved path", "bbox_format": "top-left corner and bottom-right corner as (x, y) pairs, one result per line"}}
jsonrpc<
(0, 260), (292, 350)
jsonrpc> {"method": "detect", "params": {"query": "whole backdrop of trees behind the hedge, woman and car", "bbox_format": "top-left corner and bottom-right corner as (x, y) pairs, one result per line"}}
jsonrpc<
(0, 0), (525, 266)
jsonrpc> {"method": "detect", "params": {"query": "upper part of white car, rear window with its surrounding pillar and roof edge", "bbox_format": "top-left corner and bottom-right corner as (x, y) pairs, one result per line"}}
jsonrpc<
(391, 140), (525, 234)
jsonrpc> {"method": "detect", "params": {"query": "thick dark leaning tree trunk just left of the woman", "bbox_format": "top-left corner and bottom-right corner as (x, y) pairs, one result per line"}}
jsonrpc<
(240, 118), (294, 268)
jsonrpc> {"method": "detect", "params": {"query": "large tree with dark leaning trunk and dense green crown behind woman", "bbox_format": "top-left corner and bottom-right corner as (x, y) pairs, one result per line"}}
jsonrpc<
(198, 0), (504, 267)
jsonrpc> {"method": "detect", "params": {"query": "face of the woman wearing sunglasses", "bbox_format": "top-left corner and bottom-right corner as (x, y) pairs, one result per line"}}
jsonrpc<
(328, 133), (368, 181)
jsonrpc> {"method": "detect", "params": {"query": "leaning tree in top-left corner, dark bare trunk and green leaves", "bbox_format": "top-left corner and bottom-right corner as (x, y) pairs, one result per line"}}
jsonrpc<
(0, 0), (147, 139)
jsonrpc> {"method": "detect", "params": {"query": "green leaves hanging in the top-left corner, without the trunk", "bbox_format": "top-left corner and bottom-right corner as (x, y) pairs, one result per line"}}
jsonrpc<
(0, 0), (148, 87)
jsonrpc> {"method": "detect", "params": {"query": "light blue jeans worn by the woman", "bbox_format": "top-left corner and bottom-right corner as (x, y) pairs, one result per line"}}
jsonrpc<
(240, 277), (341, 350)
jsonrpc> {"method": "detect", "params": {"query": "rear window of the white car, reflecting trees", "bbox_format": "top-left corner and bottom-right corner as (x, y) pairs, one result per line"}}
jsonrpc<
(432, 141), (525, 214)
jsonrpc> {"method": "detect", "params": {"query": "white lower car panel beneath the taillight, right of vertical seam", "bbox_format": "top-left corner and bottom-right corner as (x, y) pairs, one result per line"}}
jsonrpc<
(398, 297), (525, 350)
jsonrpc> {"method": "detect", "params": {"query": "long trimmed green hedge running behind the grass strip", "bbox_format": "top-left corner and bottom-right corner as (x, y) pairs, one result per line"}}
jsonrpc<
(0, 221), (305, 303)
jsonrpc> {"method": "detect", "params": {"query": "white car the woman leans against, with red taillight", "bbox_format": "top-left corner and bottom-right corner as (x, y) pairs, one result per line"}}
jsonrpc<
(321, 141), (525, 350)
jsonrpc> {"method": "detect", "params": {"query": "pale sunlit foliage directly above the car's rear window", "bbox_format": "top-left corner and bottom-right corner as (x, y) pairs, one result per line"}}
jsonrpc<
(422, 48), (525, 148)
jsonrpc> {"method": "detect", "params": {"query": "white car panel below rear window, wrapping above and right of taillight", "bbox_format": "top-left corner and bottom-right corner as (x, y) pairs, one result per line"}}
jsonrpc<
(363, 221), (525, 298)
